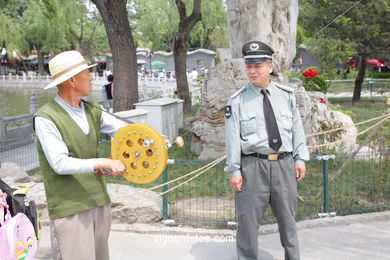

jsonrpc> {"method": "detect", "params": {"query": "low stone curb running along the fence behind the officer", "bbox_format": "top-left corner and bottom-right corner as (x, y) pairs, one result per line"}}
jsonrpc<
(111, 211), (390, 236)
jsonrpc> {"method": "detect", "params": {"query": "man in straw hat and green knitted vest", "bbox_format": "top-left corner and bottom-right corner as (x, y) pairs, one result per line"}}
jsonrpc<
(34, 51), (126, 260)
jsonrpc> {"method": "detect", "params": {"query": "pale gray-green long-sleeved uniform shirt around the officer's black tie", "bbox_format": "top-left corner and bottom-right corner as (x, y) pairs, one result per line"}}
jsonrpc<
(225, 82), (309, 177)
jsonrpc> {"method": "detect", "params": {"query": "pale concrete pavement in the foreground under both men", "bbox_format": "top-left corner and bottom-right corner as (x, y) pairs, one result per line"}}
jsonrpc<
(37, 211), (390, 260)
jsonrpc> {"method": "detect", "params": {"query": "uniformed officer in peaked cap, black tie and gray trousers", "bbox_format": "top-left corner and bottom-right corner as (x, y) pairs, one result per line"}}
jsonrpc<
(225, 41), (309, 260)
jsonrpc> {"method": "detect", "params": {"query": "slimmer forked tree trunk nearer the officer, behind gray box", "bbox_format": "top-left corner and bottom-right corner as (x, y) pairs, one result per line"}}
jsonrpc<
(173, 0), (202, 112)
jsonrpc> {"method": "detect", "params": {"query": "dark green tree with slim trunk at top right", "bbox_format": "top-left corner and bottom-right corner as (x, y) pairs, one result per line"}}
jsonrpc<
(300, 0), (390, 104)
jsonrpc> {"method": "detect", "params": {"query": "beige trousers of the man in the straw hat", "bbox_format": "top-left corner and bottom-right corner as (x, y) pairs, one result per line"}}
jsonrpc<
(50, 204), (111, 260)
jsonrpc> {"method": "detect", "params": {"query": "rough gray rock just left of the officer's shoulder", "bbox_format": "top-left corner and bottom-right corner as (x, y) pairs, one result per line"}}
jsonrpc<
(184, 59), (248, 159)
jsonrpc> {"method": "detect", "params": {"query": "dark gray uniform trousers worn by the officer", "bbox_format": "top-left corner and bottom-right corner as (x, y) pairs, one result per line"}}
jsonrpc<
(236, 155), (300, 260)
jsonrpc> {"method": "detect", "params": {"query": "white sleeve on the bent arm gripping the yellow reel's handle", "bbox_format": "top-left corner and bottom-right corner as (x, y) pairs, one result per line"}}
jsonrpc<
(34, 116), (95, 175)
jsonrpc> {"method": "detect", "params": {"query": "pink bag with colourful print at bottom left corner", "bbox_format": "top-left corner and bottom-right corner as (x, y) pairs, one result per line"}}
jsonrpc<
(0, 191), (37, 260)
